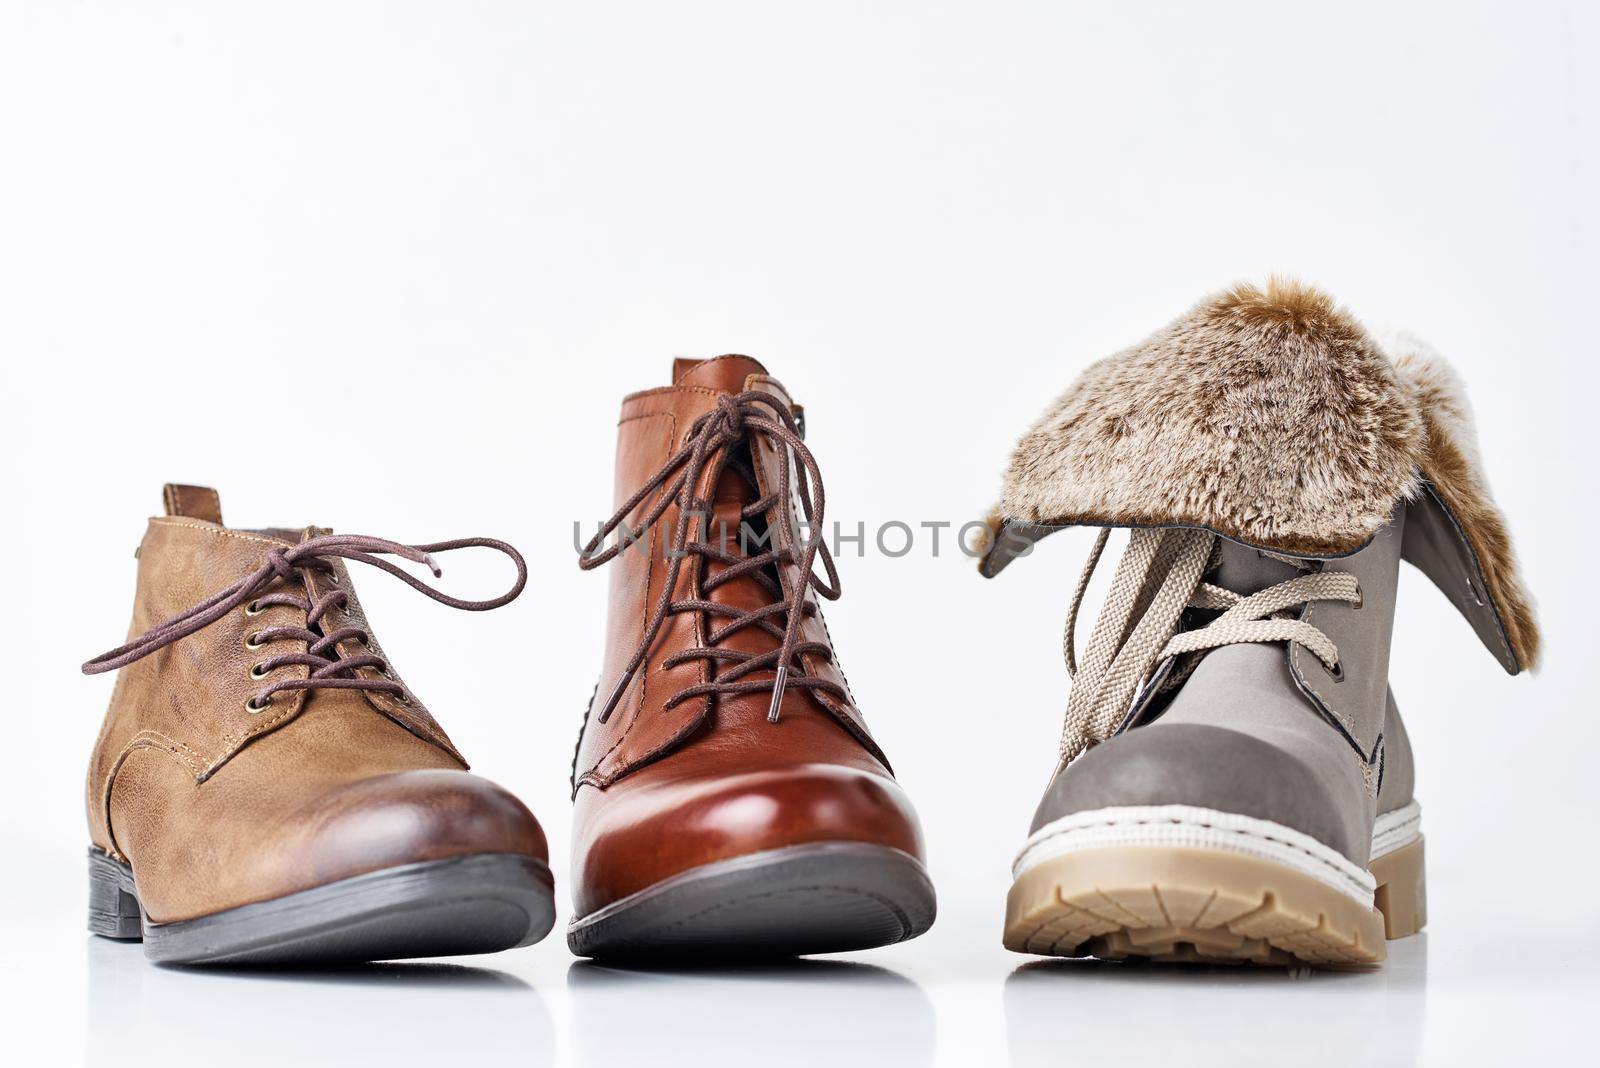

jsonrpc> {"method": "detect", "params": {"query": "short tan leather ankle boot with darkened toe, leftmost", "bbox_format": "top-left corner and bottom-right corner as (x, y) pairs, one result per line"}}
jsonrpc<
(83, 486), (555, 962)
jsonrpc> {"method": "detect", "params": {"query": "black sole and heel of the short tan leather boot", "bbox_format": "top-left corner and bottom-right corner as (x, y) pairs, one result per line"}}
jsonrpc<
(90, 849), (555, 964)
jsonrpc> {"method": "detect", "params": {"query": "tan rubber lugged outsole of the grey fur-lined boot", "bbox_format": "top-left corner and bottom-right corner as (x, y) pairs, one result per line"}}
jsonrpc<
(1005, 838), (1427, 964)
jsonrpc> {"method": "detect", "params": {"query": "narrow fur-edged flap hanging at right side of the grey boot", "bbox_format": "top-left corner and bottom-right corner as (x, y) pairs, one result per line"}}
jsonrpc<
(1382, 334), (1539, 668)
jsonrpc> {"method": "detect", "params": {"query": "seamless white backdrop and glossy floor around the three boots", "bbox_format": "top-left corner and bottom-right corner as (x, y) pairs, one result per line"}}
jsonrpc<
(0, 0), (1600, 1065)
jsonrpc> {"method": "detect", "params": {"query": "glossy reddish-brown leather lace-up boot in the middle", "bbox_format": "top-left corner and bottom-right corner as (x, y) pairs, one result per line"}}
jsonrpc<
(566, 357), (934, 956)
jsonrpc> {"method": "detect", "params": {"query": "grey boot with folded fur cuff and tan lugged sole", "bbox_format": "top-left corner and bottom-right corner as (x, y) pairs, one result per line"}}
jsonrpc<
(982, 283), (1538, 962)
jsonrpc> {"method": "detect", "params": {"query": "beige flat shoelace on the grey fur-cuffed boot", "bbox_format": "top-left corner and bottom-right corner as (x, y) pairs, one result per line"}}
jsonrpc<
(1061, 528), (1362, 761)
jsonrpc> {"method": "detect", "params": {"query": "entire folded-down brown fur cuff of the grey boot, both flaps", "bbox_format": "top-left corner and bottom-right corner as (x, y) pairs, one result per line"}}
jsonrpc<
(981, 280), (1539, 673)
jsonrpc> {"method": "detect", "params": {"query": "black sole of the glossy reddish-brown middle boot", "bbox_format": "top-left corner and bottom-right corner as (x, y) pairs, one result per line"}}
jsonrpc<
(566, 843), (936, 959)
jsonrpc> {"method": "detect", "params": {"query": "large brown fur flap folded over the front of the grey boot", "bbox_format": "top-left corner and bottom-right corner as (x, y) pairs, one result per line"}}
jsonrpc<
(1003, 280), (1424, 555)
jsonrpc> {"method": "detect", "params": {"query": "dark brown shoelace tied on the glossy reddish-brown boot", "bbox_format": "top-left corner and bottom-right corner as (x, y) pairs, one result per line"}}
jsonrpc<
(578, 390), (850, 723)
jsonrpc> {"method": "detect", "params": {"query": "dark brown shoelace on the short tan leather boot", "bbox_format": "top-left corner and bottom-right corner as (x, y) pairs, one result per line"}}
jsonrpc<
(83, 534), (528, 711)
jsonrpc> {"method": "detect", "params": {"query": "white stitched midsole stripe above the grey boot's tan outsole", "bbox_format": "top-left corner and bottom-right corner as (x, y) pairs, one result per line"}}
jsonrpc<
(1011, 801), (1422, 905)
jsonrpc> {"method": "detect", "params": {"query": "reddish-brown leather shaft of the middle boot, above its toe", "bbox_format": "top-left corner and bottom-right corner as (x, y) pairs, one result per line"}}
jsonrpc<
(573, 355), (886, 791)
